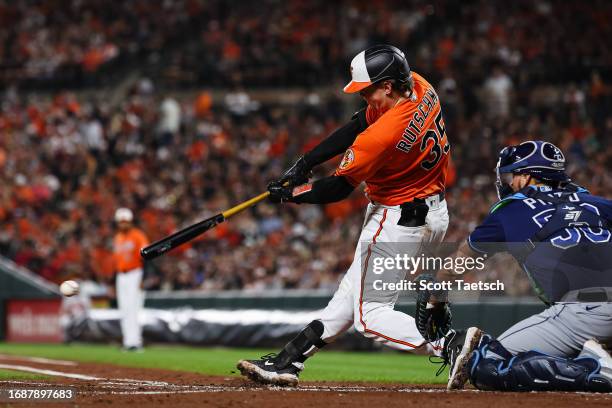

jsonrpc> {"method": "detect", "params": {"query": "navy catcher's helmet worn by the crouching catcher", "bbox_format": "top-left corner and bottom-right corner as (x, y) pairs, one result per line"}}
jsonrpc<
(495, 140), (571, 199)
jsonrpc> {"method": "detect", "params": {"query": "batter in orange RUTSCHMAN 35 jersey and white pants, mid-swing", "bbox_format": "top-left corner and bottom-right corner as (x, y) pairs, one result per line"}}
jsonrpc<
(238, 45), (450, 385)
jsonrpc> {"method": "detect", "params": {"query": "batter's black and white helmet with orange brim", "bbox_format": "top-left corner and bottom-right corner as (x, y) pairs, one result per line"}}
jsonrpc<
(344, 44), (412, 93)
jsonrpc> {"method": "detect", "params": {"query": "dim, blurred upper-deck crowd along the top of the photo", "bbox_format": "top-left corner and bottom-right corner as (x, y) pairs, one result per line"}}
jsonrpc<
(0, 0), (612, 90)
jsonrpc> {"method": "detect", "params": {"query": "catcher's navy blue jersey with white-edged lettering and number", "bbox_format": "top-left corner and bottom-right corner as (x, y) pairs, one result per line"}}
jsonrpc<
(468, 186), (612, 303)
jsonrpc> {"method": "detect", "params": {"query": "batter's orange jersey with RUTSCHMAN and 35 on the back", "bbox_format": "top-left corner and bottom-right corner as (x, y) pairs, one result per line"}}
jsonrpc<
(336, 72), (450, 205)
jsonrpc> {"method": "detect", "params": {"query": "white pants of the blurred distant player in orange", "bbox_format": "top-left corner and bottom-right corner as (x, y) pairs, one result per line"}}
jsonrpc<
(117, 268), (144, 348)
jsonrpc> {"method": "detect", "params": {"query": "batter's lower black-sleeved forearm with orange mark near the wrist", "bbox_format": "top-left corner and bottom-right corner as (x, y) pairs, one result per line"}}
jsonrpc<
(291, 176), (355, 204)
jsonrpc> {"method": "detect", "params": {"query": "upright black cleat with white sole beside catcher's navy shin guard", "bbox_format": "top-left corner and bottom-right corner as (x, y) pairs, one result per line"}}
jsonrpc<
(442, 327), (483, 390)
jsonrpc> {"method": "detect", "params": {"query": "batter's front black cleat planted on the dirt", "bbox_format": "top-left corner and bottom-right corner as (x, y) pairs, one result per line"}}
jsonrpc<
(236, 353), (304, 387)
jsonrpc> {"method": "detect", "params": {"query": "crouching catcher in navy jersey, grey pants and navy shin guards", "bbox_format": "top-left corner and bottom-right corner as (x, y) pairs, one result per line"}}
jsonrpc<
(443, 141), (612, 392)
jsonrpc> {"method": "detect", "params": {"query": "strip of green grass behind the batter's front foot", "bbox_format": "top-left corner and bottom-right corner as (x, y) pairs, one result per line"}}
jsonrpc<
(0, 343), (445, 383)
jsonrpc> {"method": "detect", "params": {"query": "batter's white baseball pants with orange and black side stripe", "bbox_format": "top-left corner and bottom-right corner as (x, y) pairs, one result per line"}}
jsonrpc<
(320, 199), (448, 354)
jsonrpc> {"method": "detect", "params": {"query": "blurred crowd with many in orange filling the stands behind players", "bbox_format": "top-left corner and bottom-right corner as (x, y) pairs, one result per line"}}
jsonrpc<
(0, 1), (612, 294)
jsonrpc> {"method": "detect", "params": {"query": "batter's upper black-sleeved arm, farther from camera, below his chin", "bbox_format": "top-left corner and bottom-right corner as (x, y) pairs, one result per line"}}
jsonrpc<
(304, 109), (368, 168)
